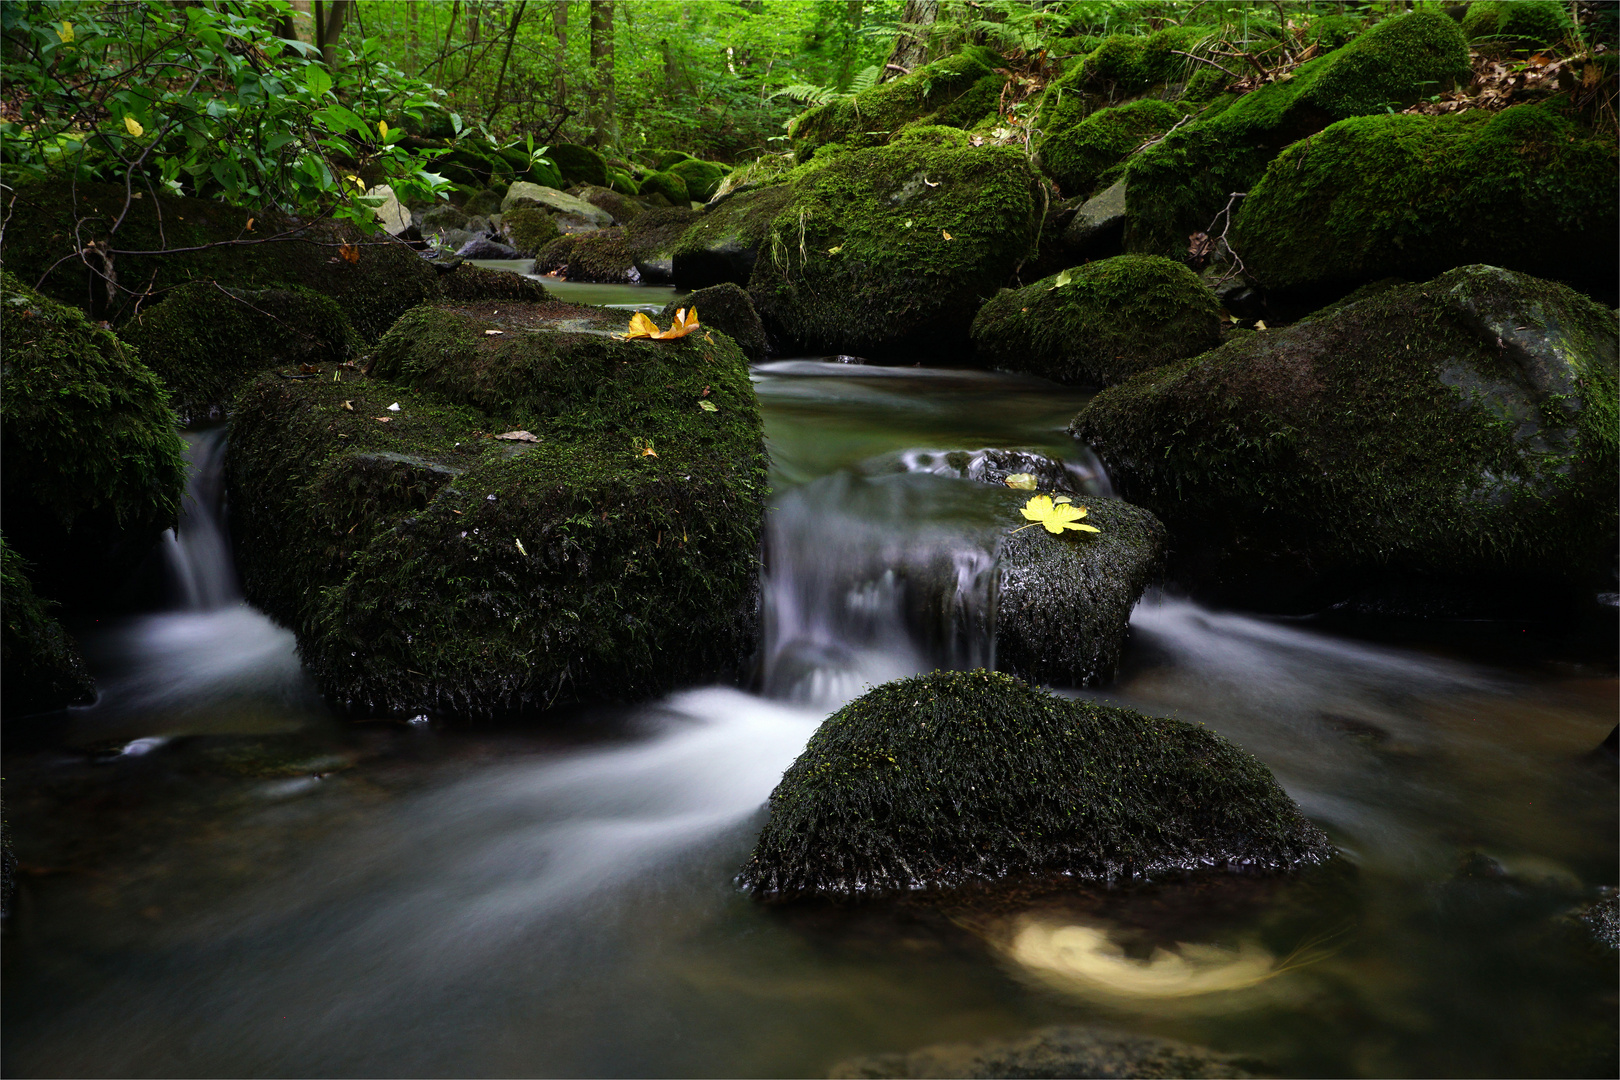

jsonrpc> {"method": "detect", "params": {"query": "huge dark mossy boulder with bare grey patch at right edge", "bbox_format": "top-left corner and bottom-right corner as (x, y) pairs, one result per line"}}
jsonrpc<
(1071, 266), (1620, 612)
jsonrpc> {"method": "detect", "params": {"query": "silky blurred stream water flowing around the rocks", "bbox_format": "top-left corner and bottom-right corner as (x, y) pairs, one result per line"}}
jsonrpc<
(3, 287), (1620, 1075)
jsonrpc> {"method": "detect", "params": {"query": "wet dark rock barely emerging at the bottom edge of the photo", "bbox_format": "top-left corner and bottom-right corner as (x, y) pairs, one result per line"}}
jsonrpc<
(828, 1027), (1264, 1080)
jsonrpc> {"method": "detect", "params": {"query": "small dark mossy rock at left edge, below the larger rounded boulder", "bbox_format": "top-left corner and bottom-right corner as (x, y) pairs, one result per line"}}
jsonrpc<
(0, 536), (96, 717)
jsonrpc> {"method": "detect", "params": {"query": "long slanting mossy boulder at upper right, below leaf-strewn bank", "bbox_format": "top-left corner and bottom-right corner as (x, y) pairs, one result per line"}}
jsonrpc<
(1126, 11), (1471, 254)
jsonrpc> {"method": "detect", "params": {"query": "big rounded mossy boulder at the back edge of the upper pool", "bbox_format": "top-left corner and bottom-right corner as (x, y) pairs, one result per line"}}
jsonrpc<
(748, 142), (1045, 355)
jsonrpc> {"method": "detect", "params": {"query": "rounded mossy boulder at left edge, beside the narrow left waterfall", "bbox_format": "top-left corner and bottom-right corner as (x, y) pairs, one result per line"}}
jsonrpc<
(0, 272), (186, 607)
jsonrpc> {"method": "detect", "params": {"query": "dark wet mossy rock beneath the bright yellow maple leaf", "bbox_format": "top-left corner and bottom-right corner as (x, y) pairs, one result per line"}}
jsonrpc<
(996, 491), (1166, 687)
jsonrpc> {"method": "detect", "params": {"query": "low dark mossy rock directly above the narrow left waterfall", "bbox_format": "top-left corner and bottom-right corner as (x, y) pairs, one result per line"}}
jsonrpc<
(122, 282), (360, 419)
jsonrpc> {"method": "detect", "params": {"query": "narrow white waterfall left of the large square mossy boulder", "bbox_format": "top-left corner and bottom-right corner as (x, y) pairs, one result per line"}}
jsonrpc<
(164, 426), (241, 612)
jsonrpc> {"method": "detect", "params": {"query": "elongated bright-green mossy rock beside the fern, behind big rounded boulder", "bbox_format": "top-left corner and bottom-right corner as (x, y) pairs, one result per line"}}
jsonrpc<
(787, 45), (1006, 162)
